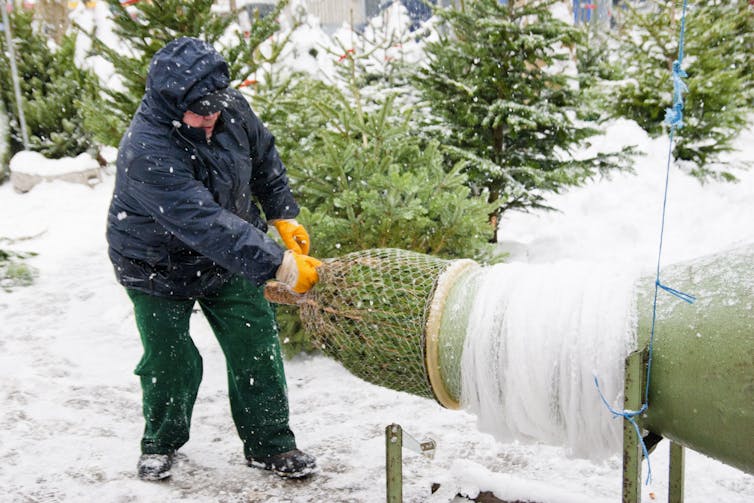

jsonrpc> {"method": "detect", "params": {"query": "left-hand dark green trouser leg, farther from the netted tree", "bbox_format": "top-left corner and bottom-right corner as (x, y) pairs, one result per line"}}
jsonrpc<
(128, 290), (202, 454)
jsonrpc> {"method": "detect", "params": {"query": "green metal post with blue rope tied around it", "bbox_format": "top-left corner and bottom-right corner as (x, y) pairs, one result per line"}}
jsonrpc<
(622, 351), (644, 503)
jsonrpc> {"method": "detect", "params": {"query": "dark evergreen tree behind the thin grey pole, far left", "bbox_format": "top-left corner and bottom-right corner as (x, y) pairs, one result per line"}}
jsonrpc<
(0, 9), (99, 159)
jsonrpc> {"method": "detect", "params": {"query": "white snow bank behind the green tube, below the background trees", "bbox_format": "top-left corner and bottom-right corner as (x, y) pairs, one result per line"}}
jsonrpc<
(498, 120), (754, 270)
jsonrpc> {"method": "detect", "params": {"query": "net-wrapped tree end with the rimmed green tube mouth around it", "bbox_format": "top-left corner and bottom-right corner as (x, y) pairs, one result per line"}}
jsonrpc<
(266, 248), (480, 408)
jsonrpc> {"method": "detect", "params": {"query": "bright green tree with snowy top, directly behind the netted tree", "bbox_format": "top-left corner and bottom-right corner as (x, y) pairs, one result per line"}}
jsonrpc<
(254, 10), (491, 260)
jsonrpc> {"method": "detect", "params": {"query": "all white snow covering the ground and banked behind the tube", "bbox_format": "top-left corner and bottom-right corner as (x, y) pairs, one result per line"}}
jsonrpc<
(0, 122), (754, 503)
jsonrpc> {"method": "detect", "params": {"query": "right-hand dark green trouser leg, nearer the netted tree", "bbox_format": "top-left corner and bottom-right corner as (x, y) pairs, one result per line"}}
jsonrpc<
(199, 277), (296, 458)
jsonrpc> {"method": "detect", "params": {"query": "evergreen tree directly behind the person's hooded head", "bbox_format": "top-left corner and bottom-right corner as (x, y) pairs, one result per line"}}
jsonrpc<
(84, 0), (288, 146)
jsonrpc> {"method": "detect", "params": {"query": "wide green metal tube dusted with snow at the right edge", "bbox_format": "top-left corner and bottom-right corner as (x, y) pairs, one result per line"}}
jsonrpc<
(637, 246), (754, 473)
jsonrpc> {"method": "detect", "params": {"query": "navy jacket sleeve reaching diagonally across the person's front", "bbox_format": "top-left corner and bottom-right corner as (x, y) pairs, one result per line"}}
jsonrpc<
(127, 154), (284, 285)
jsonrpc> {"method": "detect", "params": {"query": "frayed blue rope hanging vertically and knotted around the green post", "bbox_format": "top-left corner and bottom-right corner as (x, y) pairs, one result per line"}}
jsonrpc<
(594, 0), (696, 485)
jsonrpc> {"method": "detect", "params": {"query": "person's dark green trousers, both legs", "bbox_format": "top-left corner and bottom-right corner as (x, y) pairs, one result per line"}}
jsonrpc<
(127, 277), (296, 459)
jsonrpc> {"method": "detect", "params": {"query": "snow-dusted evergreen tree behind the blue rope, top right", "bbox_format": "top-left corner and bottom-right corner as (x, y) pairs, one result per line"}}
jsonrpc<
(614, 0), (754, 180)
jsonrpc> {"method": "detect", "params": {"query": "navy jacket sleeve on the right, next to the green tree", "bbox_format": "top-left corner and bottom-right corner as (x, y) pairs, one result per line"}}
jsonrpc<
(244, 100), (299, 220)
